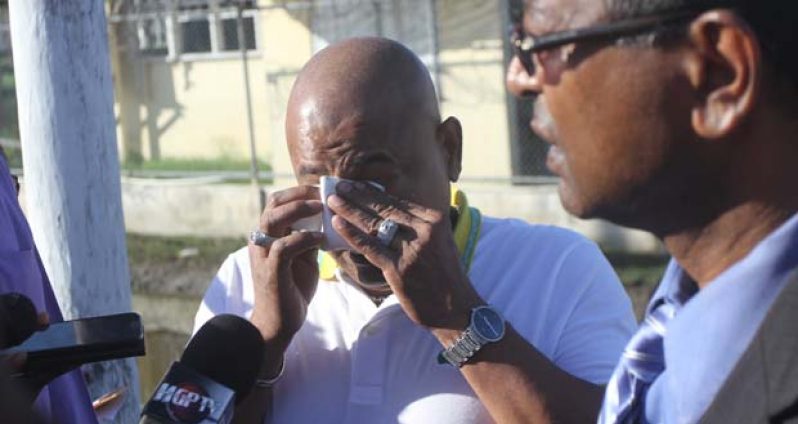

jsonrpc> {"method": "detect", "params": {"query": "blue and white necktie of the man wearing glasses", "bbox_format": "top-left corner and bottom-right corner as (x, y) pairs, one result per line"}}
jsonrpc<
(599, 301), (676, 424)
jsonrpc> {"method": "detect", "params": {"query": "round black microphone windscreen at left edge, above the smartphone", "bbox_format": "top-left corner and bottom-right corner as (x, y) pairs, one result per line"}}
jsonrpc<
(0, 293), (39, 349)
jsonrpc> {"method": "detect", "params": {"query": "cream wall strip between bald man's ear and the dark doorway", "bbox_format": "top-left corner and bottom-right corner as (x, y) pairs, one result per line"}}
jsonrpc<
(437, 0), (512, 179)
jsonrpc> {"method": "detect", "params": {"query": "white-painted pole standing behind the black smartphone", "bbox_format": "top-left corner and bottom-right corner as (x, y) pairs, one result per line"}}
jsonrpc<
(9, 0), (139, 423)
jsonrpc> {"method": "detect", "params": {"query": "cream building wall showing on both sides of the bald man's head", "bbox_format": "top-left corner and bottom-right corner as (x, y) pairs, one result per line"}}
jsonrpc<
(115, 0), (511, 181)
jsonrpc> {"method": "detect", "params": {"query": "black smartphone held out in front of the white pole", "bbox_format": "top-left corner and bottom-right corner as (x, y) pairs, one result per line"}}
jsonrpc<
(0, 312), (145, 373)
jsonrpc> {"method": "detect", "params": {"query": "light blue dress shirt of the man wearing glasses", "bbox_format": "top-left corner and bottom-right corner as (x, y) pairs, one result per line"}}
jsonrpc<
(645, 215), (798, 423)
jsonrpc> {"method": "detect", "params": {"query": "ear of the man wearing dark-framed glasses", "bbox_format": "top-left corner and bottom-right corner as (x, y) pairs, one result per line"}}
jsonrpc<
(687, 11), (762, 140)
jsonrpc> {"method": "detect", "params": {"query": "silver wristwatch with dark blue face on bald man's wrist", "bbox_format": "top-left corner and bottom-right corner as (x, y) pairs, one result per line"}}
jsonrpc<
(438, 306), (505, 368)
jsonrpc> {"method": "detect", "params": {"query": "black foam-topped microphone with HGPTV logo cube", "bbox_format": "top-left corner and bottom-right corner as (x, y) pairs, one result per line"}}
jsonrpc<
(139, 314), (265, 424)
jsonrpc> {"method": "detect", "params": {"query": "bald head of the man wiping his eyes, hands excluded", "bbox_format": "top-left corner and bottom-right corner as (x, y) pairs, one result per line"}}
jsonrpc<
(286, 38), (461, 284)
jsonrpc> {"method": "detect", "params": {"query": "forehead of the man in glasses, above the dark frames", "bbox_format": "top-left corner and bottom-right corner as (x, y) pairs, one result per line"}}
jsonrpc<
(524, 0), (607, 35)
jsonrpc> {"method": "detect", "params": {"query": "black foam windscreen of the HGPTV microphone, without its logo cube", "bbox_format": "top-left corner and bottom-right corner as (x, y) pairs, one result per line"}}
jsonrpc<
(180, 314), (265, 403)
